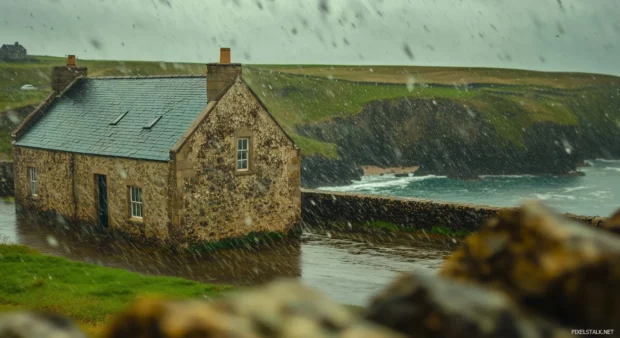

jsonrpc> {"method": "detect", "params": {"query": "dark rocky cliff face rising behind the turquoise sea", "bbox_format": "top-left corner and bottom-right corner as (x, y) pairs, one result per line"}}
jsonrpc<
(297, 98), (620, 185)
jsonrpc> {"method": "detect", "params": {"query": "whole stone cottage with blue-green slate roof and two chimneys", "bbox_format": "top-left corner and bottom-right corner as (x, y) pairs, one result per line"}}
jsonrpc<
(13, 48), (301, 244)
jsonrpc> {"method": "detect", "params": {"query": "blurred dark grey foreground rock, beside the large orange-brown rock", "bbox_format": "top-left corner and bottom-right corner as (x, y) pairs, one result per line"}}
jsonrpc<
(365, 274), (570, 338)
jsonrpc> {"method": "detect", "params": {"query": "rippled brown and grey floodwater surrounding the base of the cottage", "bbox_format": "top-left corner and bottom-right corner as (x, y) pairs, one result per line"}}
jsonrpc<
(0, 202), (455, 305)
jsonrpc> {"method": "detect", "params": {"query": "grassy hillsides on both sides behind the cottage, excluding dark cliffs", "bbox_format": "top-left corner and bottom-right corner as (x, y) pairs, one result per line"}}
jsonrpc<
(0, 57), (620, 178)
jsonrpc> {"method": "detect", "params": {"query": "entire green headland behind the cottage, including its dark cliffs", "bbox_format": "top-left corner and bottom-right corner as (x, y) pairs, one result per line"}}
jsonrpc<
(0, 57), (620, 187)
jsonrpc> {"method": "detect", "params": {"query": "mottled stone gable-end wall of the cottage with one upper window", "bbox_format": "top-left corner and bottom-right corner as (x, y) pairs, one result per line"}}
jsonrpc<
(173, 82), (301, 243)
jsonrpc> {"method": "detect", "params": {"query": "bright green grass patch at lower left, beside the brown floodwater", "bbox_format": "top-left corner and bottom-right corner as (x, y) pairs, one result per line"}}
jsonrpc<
(0, 245), (233, 327)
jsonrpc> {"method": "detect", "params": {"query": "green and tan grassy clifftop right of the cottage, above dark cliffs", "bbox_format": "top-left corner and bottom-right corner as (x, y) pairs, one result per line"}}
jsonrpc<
(244, 66), (620, 157)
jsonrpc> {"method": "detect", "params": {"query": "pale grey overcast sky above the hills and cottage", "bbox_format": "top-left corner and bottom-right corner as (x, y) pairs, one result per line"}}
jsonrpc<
(0, 0), (620, 75)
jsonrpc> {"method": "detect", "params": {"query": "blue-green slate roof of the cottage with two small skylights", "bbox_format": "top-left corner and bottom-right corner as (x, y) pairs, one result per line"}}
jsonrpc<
(15, 75), (207, 161)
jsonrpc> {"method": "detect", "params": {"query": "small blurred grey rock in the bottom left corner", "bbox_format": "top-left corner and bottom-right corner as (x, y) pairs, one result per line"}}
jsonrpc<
(0, 312), (86, 338)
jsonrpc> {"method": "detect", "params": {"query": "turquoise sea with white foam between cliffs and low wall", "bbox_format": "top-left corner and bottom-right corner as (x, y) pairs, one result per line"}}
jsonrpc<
(320, 159), (620, 217)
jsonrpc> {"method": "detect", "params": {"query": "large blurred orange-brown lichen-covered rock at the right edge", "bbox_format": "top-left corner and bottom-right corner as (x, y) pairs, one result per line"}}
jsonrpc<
(440, 202), (620, 328)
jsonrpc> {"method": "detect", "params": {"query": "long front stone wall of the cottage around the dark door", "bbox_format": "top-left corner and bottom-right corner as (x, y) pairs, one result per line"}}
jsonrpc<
(13, 147), (169, 241)
